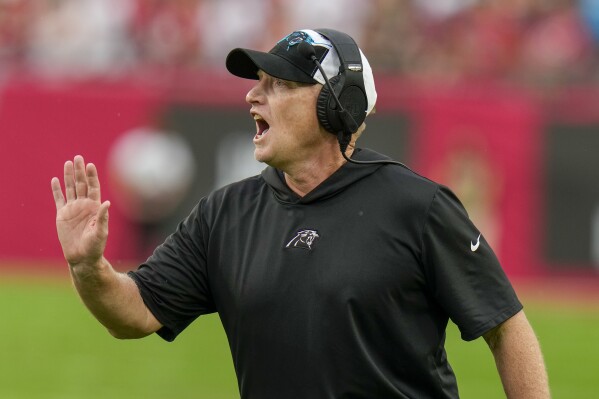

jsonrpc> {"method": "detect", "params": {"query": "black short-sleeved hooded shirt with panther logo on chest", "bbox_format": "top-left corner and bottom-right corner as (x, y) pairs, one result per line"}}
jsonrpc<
(130, 150), (522, 399)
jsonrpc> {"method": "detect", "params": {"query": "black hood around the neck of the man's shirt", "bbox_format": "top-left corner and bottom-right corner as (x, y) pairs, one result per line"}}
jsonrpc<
(262, 148), (389, 204)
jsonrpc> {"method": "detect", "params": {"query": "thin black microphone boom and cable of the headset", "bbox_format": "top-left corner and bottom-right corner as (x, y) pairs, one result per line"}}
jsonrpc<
(297, 40), (409, 169)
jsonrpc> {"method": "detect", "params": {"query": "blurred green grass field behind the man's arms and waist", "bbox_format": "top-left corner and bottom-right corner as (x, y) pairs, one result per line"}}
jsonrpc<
(0, 275), (599, 399)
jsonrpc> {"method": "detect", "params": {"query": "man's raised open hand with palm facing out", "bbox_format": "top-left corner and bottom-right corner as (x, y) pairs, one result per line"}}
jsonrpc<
(51, 155), (110, 267)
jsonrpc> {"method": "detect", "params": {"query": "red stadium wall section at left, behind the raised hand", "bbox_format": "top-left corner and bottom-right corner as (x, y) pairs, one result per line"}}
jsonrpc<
(0, 82), (164, 268)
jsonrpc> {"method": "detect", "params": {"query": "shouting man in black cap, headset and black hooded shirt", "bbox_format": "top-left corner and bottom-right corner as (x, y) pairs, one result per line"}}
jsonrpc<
(52, 30), (549, 399)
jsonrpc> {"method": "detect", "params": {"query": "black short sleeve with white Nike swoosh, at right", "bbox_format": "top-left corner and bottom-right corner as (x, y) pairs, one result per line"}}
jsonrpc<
(422, 186), (522, 341)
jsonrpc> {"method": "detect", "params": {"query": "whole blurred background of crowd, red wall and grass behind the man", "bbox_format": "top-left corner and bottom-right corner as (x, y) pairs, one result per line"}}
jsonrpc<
(0, 0), (599, 398)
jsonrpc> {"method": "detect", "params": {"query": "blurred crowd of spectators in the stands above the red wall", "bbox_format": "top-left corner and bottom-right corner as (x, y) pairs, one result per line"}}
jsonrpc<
(0, 0), (599, 86)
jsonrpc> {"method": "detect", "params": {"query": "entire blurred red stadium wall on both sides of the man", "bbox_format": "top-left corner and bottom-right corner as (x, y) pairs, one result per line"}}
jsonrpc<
(0, 76), (599, 275)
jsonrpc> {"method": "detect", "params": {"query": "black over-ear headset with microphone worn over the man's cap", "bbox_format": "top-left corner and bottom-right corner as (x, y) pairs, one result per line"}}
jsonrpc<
(298, 29), (406, 167)
